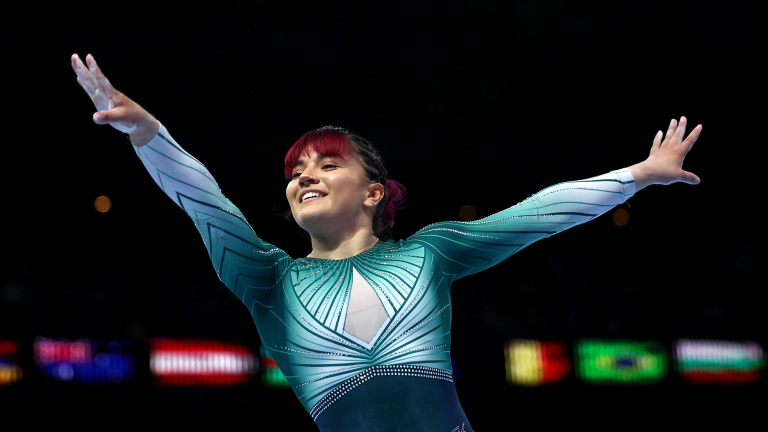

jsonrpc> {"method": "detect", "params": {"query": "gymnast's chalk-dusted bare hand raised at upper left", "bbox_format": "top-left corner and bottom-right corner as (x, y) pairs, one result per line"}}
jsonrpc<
(72, 54), (160, 146)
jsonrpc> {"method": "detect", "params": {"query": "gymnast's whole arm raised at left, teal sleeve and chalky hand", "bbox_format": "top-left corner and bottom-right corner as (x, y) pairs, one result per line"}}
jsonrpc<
(72, 55), (291, 316)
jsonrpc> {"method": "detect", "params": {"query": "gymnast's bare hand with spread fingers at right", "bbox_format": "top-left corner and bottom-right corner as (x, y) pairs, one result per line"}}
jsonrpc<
(629, 117), (702, 191)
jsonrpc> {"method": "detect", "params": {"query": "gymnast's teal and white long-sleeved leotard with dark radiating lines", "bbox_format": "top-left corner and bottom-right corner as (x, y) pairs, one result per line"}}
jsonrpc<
(136, 126), (635, 432)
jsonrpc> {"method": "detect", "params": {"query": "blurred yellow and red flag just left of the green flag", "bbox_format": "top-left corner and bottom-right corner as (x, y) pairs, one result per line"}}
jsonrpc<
(504, 339), (571, 386)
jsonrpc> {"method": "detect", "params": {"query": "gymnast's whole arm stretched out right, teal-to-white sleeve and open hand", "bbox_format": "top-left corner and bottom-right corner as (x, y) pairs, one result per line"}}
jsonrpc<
(407, 117), (701, 279)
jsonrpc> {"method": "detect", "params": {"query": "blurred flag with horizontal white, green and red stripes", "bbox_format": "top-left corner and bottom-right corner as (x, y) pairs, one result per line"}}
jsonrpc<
(672, 339), (765, 384)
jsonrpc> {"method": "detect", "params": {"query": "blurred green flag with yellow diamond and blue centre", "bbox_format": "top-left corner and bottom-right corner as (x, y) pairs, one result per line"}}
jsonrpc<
(574, 339), (667, 384)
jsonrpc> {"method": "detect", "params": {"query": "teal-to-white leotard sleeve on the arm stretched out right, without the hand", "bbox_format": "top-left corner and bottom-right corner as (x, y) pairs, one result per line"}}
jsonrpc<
(407, 169), (635, 279)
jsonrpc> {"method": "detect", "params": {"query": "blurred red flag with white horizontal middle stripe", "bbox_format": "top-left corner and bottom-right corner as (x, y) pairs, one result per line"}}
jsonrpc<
(149, 339), (258, 386)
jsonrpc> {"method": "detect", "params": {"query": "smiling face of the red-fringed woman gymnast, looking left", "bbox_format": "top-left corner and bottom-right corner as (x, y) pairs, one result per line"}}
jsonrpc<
(285, 149), (383, 236)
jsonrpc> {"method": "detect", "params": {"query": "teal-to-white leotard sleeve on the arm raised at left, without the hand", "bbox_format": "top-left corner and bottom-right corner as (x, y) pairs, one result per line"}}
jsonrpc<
(135, 125), (291, 326)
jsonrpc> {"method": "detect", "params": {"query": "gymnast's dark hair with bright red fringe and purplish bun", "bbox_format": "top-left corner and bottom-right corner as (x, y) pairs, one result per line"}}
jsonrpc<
(284, 126), (405, 240)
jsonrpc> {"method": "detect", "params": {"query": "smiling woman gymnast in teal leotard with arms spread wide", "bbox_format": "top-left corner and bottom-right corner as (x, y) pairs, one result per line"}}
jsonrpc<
(72, 55), (701, 432)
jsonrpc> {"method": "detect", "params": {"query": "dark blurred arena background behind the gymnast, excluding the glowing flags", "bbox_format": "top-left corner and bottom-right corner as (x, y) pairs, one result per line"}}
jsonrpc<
(0, 0), (768, 431)
